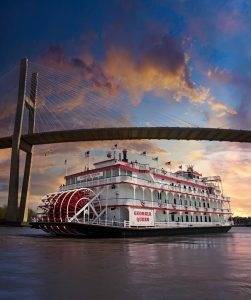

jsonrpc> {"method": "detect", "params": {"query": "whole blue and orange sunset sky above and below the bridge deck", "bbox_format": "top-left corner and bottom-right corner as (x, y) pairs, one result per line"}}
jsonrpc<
(0, 0), (251, 216)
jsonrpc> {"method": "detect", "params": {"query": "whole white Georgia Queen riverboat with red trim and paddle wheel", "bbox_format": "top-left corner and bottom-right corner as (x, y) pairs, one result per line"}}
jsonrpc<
(31, 150), (233, 237)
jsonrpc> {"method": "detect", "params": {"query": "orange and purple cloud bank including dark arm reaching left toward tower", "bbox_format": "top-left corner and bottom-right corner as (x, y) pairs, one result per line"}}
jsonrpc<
(41, 32), (214, 109)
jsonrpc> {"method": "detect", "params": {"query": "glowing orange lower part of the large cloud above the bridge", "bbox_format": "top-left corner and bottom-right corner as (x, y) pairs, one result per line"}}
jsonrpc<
(103, 47), (209, 105)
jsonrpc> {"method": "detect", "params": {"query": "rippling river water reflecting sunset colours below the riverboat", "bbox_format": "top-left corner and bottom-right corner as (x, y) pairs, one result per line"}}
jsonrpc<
(0, 227), (251, 300)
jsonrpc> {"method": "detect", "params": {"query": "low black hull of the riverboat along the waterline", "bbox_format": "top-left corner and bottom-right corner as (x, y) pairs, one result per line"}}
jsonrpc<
(30, 222), (231, 237)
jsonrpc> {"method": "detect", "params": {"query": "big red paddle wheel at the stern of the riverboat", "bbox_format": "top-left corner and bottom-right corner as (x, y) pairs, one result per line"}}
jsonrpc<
(36, 188), (101, 233)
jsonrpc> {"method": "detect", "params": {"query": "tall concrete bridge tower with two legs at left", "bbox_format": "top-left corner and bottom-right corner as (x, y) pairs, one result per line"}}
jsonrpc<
(5, 58), (38, 224)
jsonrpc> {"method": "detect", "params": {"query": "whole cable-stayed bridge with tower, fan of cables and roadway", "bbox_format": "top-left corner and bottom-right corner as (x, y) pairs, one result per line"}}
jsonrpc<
(0, 59), (251, 223)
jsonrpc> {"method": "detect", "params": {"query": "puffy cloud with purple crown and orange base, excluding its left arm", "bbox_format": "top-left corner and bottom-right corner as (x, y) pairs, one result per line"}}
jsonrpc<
(103, 34), (208, 105)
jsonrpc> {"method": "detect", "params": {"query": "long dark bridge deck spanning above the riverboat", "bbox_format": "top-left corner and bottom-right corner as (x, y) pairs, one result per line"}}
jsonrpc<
(0, 127), (251, 149)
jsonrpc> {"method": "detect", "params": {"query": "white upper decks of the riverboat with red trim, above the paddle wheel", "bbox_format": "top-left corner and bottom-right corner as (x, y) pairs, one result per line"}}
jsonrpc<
(60, 151), (230, 202)
